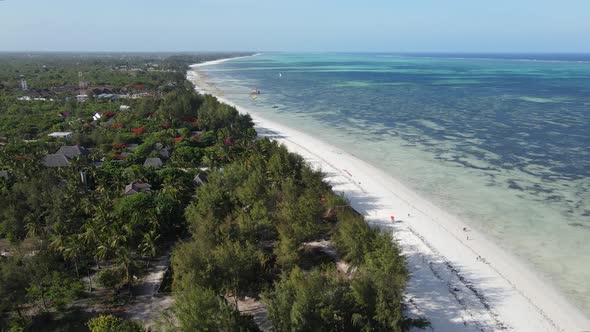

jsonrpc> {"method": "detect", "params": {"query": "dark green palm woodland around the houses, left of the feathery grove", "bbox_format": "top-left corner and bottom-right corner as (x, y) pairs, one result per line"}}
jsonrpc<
(0, 55), (255, 329)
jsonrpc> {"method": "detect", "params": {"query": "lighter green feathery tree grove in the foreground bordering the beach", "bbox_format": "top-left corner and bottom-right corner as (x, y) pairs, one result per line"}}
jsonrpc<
(164, 140), (416, 331)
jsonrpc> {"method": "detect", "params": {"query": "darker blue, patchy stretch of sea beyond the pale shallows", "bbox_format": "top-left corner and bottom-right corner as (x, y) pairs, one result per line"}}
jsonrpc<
(213, 55), (590, 226)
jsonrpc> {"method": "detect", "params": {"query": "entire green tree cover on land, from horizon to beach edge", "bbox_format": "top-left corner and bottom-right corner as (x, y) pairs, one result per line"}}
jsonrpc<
(0, 54), (415, 331)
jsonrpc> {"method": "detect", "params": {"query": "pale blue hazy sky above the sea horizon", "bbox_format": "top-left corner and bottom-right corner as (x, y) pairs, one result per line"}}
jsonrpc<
(0, 0), (590, 53)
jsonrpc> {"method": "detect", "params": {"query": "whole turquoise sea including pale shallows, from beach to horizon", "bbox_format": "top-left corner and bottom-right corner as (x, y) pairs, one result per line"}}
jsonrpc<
(204, 54), (590, 314)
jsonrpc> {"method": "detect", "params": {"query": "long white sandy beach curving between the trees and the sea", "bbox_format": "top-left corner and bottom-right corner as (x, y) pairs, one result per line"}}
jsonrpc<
(188, 60), (590, 332)
